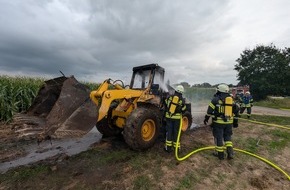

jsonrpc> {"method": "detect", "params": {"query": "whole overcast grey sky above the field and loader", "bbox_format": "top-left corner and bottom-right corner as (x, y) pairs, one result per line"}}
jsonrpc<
(0, 0), (290, 85)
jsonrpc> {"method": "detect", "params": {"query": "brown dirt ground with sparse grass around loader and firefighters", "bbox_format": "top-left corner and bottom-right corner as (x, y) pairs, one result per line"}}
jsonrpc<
(0, 106), (290, 190)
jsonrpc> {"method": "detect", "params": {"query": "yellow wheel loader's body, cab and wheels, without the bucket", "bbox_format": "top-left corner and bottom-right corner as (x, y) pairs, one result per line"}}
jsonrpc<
(90, 64), (192, 150)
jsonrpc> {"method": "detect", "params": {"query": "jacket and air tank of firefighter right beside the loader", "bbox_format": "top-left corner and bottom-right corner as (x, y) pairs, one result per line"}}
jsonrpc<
(165, 93), (186, 119)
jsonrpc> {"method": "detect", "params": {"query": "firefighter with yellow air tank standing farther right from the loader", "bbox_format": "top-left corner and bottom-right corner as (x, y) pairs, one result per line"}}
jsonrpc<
(204, 84), (239, 160)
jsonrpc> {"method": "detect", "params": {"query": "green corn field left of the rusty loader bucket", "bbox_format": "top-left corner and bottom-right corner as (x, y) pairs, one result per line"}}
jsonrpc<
(0, 76), (44, 122)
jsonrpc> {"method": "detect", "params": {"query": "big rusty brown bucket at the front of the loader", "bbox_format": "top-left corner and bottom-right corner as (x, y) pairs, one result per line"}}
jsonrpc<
(14, 76), (97, 138)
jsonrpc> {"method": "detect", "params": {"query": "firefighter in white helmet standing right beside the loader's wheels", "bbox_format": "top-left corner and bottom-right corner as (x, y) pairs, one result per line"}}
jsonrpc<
(164, 85), (186, 152)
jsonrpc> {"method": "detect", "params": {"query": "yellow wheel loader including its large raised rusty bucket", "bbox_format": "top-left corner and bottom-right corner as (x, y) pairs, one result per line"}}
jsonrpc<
(13, 64), (192, 150)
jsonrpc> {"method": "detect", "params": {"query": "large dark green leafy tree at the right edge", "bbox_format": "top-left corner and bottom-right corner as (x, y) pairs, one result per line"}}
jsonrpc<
(234, 44), (290, 100)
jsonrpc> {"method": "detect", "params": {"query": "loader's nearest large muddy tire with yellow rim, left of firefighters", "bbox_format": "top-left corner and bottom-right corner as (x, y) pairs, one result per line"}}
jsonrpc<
(123, 106), (161, 150)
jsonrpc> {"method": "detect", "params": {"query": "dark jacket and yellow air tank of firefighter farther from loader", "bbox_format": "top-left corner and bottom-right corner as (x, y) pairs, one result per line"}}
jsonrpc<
(207, 93), (239, 124)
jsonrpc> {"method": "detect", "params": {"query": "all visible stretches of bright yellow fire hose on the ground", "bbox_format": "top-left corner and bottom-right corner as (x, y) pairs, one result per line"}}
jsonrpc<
(175, 119), (290, 181)
